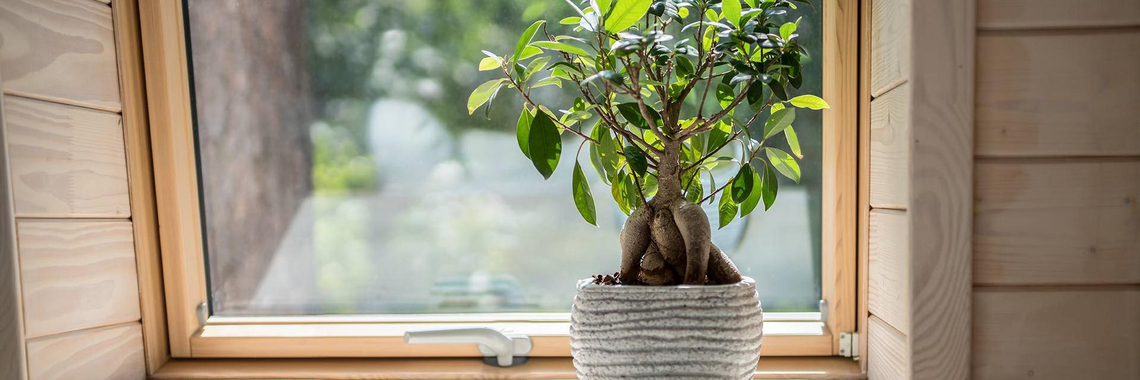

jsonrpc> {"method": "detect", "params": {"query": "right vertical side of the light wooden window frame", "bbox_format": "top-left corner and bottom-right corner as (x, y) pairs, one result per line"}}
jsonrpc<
(821, 0), (858, 355)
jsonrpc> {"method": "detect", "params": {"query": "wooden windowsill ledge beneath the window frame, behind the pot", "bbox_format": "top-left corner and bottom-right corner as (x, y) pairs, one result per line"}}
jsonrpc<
(152, 357), (866, 379)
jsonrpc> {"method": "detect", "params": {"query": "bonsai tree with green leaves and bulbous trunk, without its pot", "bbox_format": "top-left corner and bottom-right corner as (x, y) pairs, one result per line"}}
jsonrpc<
(467, 0), (828, 285)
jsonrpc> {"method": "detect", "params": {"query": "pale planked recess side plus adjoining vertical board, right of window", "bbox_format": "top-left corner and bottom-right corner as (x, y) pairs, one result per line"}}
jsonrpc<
(866, 0), (976, 379)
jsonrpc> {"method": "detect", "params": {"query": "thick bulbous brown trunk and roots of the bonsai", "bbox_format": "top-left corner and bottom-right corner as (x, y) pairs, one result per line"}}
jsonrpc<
(619, 143), (742, 285)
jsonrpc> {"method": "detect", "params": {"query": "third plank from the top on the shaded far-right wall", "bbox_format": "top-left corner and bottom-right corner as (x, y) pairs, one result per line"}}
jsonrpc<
(974, 160), (1140, 284)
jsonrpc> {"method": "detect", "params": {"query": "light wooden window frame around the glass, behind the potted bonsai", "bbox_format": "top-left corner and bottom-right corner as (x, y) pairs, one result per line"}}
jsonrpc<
(131, 0), (860, 360)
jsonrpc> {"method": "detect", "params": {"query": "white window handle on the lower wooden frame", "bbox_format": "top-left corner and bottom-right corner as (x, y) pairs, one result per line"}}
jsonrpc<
(404, 328), (531, 366)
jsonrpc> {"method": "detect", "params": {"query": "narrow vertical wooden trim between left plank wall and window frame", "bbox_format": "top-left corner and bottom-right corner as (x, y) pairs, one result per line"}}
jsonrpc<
(111, 0), (170, 374)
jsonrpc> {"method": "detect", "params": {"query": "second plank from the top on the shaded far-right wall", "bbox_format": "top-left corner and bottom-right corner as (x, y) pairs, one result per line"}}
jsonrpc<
(977, 31), (1140, 156)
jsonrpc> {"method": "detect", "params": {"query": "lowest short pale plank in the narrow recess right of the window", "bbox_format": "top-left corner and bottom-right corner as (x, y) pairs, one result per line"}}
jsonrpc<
(866, 315), (911, 380)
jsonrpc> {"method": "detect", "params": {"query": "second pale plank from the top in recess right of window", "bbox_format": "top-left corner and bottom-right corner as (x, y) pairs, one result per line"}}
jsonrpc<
(870, 84), (911, 210)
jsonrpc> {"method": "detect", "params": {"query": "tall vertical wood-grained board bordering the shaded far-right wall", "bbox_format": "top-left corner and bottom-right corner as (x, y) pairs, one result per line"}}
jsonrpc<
(907, 0), (975, 379)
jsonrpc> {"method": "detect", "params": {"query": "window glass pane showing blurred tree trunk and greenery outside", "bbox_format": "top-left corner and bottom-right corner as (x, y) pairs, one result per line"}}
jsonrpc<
(188, 0), (822, 315)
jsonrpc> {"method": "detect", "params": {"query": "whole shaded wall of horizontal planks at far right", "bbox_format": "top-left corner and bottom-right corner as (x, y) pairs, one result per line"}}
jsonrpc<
(972, 0), (1140, 379)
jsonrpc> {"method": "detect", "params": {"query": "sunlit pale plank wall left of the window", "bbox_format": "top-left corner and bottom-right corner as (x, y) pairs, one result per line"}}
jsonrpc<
(0, 0), (146, 379)
